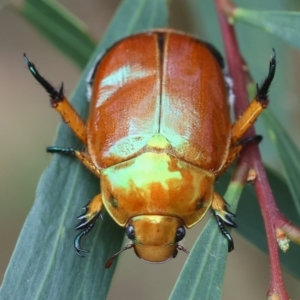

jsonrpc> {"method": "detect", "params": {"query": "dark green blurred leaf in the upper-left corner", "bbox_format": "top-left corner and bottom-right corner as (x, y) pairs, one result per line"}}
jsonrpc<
(19, 0), (96, 69)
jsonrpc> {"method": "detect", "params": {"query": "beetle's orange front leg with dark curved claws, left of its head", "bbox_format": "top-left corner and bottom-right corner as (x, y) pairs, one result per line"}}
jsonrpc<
(74, 194), (103, 256)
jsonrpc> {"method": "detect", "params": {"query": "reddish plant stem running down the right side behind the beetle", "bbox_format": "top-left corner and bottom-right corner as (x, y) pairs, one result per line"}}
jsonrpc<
(215, 0), (290, 300)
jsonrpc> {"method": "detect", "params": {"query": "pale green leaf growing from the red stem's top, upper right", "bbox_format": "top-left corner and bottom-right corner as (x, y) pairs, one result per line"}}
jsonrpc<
(233, 8), (300, 49)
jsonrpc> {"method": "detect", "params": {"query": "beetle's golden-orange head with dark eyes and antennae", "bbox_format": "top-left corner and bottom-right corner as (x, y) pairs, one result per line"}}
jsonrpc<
(106, 215), (188, 267)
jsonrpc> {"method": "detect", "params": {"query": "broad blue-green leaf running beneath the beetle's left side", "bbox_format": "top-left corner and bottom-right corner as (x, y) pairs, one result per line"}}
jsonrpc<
(0, 0), (167, 300)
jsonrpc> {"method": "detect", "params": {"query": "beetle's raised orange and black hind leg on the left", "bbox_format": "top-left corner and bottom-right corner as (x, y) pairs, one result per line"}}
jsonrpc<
(24, 54), (87, 145)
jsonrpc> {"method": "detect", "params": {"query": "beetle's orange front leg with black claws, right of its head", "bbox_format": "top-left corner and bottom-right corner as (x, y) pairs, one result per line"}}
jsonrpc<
(211, 192), (237, 252)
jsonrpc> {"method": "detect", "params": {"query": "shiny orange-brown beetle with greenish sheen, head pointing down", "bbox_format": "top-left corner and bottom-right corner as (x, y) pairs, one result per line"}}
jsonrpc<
(24, 29), (276, 267)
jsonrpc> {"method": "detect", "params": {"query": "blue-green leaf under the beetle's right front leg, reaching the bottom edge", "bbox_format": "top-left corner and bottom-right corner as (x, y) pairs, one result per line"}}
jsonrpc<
(170, 182), (243, 300)
